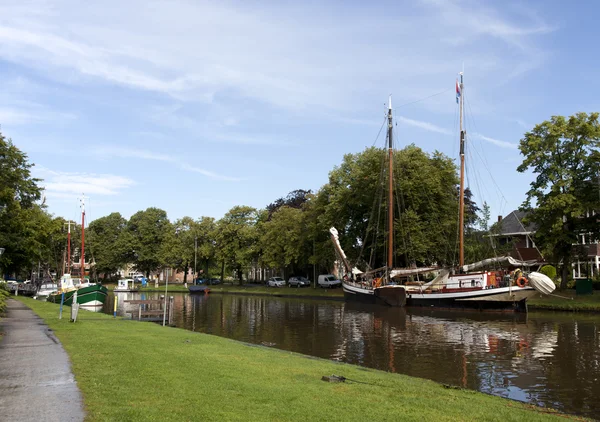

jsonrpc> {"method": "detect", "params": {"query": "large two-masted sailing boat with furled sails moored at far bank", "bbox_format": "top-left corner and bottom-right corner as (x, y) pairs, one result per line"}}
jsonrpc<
(330, 79), (555, 312)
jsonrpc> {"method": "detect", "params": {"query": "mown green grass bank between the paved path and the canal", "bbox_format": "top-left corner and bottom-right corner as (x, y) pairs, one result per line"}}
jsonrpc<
(18, 297), (576, 422)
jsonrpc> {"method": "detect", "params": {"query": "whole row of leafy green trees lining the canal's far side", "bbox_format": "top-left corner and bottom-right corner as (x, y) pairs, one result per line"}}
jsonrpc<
(0, 113), (600, 283)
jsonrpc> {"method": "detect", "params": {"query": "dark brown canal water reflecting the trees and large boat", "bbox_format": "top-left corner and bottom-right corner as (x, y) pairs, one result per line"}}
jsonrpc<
(104, 293), (600, 419)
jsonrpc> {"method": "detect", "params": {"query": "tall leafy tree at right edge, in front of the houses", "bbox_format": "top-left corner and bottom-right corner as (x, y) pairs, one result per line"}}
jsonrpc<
(517, 113), (600, 289)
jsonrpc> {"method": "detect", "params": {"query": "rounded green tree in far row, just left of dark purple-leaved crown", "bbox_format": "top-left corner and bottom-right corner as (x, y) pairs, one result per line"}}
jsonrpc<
(216, 206), (258, 285)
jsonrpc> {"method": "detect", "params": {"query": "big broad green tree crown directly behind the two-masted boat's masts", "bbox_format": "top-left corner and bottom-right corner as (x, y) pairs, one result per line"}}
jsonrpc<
(317, 145), (458, 267)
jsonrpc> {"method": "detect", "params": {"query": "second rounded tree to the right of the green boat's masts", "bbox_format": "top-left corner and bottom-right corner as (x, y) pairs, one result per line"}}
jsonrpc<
(126, 208), (172, 277)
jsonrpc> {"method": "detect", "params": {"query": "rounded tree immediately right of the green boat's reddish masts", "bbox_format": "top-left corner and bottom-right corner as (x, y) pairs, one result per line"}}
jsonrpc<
(86, 212), (130, 278)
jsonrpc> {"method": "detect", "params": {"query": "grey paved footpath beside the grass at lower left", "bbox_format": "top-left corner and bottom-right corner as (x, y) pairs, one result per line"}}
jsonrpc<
(0, 299), (85, 422)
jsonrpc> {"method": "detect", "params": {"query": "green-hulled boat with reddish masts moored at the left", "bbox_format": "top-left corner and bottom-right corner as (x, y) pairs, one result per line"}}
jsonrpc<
(47, 198), (108, 311)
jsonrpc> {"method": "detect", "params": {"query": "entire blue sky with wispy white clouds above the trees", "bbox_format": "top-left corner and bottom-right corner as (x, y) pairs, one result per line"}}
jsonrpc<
(0, 0), (600, 224)
